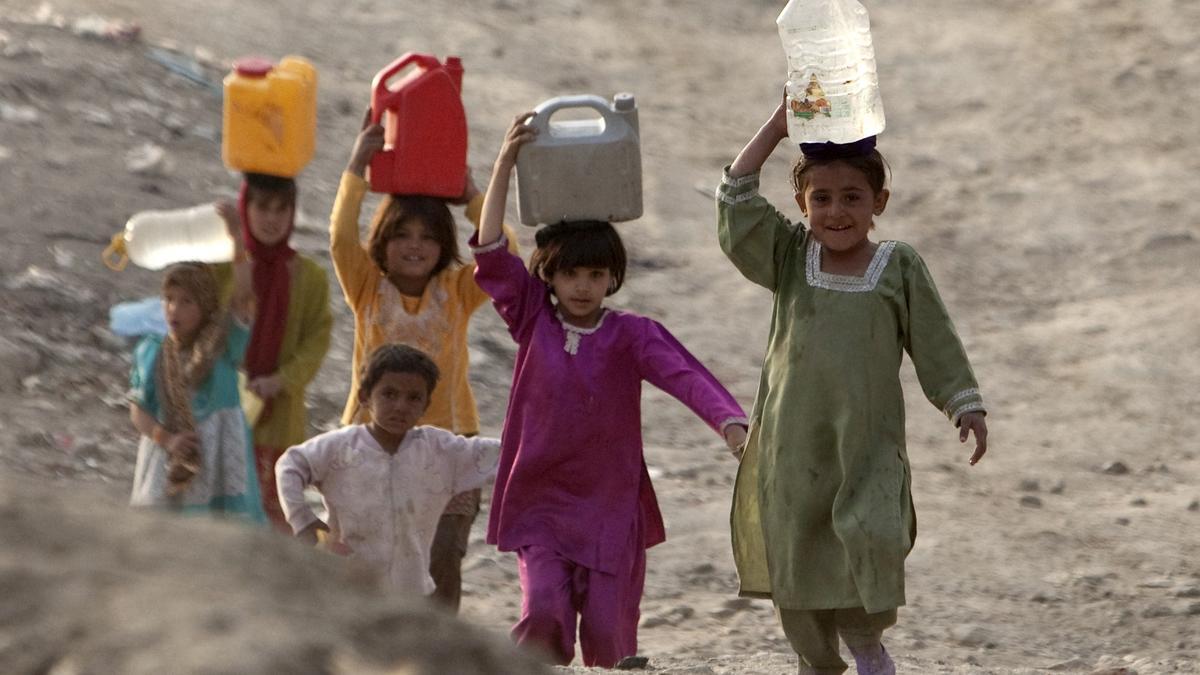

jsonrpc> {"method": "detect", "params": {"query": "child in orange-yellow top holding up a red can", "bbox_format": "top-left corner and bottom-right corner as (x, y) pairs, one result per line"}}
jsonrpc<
(330, 112), (520, 611)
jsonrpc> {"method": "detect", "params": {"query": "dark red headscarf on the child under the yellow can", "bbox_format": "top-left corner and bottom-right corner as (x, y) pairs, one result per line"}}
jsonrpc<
(238, 180), (296, 380)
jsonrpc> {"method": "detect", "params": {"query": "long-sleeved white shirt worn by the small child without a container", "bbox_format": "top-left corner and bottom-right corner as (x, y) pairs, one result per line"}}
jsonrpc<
(275, 424), (500, 596)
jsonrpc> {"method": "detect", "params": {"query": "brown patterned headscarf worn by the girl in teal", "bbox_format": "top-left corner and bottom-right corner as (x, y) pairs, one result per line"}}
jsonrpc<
(155, 262), (229, 496)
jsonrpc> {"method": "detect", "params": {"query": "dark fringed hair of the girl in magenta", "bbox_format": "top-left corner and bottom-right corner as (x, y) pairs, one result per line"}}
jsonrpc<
(529, 220), (626, 295)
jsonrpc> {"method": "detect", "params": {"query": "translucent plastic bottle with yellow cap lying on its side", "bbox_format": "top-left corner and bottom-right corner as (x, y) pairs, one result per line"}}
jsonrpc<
(104, 204), (233, 270)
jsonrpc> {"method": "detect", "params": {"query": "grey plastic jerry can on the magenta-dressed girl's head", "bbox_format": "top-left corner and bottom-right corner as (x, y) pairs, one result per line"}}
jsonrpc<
(517, 94), (642, 226)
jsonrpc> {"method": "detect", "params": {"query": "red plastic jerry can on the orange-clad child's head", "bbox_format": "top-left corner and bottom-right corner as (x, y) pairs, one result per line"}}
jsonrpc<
(368, 53), (467, 197)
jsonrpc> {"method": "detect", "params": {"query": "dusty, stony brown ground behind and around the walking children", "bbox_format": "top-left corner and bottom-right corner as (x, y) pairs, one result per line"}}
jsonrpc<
(0, 0), (1200, 675)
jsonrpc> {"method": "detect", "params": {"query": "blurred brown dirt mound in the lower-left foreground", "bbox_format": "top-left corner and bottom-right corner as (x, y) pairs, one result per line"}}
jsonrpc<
(0, 477), (550, 675)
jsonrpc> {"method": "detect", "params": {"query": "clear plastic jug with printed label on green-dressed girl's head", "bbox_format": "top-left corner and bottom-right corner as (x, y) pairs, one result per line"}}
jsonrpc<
(775, 0), (884, 143)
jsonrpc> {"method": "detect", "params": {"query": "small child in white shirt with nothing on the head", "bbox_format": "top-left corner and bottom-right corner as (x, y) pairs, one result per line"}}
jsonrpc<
(275, 345), (500, 596)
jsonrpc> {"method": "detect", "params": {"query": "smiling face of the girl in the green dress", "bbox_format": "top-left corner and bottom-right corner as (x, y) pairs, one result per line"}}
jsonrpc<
(796, 162), (888, 253)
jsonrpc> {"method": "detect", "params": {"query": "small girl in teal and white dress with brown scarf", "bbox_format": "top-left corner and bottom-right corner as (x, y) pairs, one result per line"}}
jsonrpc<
(130, 225), (265, 522)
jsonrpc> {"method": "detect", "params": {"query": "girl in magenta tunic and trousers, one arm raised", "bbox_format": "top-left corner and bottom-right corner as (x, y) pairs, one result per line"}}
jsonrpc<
(474, 113), (746, 668)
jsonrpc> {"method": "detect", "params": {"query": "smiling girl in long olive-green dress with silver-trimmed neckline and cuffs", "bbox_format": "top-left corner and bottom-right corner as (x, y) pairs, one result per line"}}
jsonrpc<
(716, 100), (988, 674)
